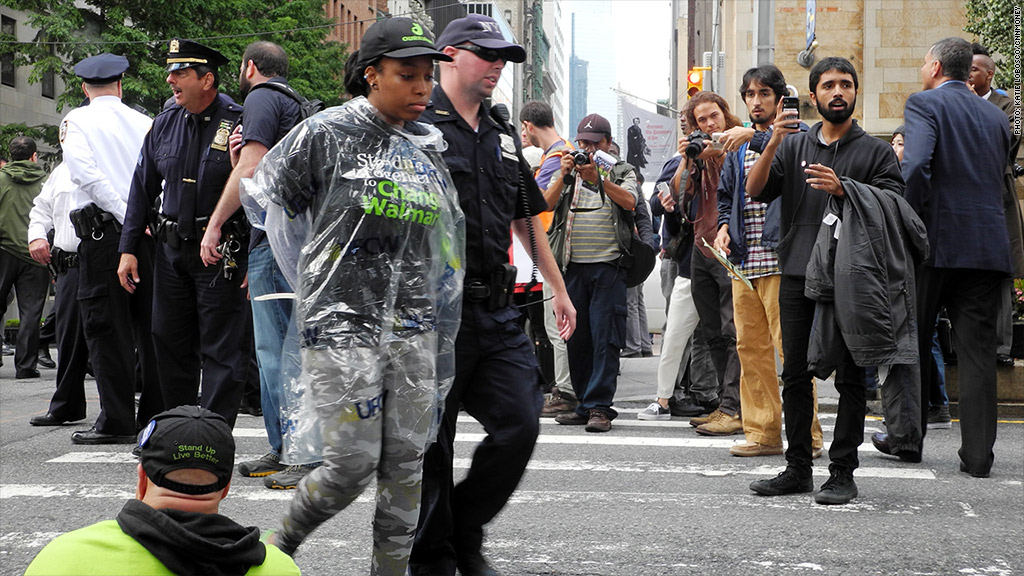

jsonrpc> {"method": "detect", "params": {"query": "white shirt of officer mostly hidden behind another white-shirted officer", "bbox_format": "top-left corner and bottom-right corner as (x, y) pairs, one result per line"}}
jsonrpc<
(29, 163), (87, 252)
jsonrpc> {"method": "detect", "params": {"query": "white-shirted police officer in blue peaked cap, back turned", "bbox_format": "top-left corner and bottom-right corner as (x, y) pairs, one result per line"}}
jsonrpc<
(59, 53), (163, 444)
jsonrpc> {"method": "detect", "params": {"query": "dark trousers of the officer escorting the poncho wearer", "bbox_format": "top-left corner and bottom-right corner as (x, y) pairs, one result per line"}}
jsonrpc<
(410, 302), (544, 576)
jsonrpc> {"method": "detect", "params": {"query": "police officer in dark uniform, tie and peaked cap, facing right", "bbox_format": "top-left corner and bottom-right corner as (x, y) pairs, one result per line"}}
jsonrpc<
(118, 38), (249, 425)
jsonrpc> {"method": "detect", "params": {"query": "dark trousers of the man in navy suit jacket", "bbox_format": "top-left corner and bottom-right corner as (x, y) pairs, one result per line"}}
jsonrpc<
(918, 266), (1006, 474)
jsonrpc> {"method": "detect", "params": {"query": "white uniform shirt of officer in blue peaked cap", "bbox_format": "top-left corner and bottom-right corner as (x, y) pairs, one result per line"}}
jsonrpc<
(59, 95), (153, 223)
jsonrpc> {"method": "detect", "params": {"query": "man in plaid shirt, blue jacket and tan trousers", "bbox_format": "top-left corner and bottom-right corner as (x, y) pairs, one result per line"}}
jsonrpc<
(715, 64), (821, 458)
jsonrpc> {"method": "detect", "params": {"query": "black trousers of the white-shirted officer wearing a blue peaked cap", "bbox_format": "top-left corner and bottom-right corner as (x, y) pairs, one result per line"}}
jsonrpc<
(78, 227), (164, 436)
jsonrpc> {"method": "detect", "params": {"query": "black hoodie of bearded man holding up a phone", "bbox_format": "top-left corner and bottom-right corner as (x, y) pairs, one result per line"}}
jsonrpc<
(758, 120), (904, 277)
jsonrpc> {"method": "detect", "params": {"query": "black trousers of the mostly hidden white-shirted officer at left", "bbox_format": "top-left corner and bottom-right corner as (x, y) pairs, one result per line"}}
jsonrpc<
(48, 266), (89, 421)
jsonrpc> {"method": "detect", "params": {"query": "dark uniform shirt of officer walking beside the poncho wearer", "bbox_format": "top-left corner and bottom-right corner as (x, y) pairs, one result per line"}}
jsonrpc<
(420, 85), (547, 279)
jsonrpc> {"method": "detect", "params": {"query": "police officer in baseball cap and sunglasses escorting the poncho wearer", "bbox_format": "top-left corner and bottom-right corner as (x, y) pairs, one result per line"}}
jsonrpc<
(410, 14), (575, 576)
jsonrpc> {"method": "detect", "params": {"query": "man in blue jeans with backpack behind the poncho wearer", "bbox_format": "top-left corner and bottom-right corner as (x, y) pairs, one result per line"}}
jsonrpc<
(200, 41), (321, 489)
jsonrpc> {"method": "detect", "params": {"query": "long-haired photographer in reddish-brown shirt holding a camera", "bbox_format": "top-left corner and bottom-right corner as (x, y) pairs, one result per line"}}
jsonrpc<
(663, 92), (743, 436)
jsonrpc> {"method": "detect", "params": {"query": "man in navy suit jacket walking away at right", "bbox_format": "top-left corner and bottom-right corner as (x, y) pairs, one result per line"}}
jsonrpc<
(903, 38), (1012, 478)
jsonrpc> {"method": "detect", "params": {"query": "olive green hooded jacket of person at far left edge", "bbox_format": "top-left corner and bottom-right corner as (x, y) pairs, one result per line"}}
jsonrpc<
(0, 160), (46, 266)
